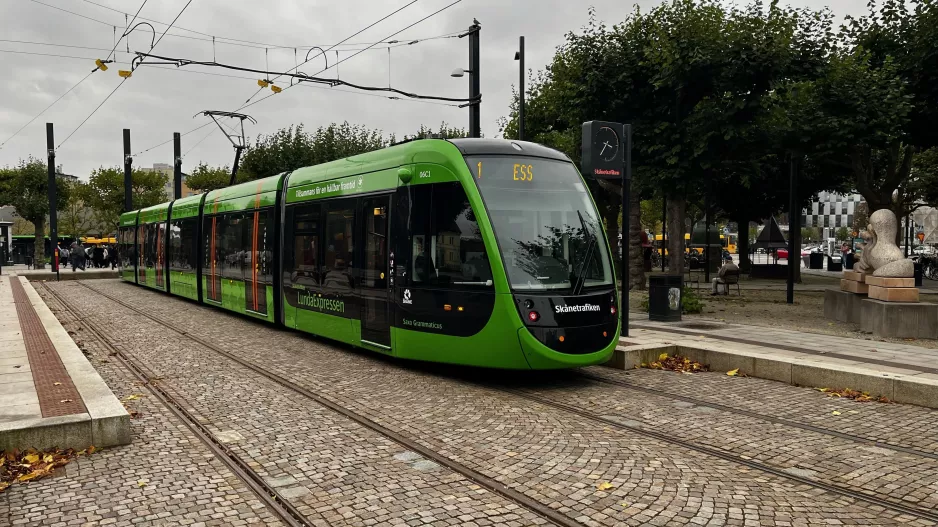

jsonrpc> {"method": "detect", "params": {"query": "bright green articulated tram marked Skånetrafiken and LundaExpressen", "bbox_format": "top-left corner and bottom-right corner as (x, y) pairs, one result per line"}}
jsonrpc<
(118, 139), (620, 369)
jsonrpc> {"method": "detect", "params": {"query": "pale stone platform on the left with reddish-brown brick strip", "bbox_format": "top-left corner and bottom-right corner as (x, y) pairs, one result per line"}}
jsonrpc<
(0, 275), (131, 450)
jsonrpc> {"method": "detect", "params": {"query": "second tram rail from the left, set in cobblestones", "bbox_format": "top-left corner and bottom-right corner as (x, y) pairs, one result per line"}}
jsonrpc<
(69, 280), (584, 527)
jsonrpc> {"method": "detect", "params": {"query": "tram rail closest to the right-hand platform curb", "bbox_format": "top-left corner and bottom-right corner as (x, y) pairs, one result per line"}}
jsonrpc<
(577, 372), (938, 460)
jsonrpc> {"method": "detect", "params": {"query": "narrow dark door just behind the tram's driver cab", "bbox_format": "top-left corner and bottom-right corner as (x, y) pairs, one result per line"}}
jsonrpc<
(359, 196), (391, 348)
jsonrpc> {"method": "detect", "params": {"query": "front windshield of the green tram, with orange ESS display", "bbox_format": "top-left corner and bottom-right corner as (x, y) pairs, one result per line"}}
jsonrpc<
(466, 156), (613, 294)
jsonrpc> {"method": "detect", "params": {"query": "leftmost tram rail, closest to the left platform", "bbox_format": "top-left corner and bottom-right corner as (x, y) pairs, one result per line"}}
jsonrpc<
(43, 283), (314, 527)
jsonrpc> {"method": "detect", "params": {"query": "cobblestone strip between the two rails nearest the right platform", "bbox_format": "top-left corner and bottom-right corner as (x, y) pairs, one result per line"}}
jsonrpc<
(512, 370), (938, 510)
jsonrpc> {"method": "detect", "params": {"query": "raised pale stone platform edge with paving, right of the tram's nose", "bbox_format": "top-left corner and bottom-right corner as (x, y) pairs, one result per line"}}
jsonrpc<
(605, 320), (938, 408)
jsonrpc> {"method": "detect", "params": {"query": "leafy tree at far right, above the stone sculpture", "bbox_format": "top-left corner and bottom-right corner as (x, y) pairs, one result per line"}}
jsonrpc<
(780, 0), (938, 234)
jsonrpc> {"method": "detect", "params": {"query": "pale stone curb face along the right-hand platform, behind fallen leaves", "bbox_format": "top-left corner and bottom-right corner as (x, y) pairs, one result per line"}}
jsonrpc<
(605, 341), (938, 408)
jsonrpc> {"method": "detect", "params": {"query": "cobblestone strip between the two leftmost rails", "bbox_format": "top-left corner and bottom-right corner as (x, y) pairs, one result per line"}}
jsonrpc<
(34, 285), (544, 527)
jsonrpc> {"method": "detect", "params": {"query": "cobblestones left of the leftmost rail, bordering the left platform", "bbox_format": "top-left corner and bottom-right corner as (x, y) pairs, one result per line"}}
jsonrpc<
(0, 288), (282, 527)
